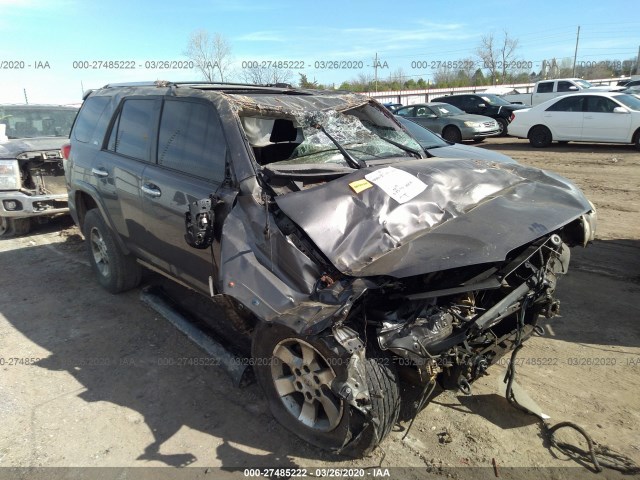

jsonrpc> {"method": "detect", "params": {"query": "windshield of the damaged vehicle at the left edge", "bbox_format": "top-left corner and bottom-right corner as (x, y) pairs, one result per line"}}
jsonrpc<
(0, 105), (77, 138)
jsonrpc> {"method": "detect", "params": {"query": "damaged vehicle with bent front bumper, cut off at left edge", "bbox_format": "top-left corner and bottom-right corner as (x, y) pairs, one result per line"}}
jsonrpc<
(0, 105), (78, 237)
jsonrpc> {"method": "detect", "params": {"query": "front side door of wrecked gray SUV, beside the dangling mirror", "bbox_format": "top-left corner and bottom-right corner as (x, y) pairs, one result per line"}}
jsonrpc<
(141, 98), (227, 292)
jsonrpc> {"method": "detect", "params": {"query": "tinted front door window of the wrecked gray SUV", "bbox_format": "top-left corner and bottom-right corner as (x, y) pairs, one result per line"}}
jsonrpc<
(158, 99), (227, 182)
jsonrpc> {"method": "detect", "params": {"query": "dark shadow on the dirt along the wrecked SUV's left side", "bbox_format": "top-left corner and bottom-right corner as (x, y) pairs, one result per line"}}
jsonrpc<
(0, 236), (348, 469)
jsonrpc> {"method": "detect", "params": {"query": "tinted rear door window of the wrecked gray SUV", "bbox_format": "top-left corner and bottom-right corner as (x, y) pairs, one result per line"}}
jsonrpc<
(107, 98), (155, 161)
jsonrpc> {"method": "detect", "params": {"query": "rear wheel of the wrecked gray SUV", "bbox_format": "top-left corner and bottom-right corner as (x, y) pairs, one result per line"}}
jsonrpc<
(83, 209), (141, 293)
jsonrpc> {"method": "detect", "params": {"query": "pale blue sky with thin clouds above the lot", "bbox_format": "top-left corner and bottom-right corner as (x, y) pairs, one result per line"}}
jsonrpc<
(0, 0), (640, 104)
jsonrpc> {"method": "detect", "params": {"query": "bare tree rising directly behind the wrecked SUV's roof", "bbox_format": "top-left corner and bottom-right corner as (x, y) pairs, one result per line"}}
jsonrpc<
(184, 30), (232, 82)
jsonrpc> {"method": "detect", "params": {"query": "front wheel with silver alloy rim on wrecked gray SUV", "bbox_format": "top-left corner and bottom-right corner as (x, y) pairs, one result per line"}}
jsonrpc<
(252, 323), (400, 457)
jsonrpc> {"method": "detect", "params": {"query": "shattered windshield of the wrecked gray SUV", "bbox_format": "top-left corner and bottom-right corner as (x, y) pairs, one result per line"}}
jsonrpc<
(270, 110), (420, 166)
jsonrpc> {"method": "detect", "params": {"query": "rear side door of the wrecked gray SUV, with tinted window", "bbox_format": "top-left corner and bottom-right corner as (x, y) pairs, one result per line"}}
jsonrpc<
(91, 96), (161, 253)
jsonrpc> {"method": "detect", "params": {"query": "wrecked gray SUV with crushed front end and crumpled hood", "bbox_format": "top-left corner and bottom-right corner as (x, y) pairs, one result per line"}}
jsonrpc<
(66, 82), (596, 455)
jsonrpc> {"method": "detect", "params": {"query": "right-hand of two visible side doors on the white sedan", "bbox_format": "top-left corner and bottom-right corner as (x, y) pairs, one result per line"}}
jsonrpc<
(582, 95), (631, 142)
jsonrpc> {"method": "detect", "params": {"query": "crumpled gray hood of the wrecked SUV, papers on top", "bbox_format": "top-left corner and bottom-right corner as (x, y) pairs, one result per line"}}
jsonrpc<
(276, 158), (591, 277)
